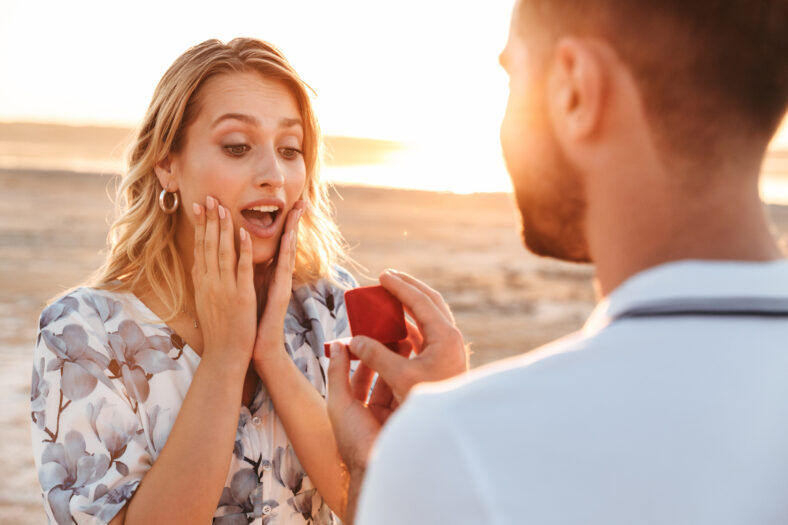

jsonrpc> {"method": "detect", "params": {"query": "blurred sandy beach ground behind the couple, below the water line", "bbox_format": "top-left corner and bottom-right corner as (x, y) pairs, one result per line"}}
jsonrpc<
(0, 165), (788, 524)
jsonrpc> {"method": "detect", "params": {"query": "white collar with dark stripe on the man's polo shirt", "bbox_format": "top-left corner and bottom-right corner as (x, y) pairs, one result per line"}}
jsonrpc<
(583, 259), (788, 333)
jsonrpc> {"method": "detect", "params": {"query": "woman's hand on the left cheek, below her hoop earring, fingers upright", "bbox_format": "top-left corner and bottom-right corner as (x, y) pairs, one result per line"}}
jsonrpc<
(192, 196), (257, 373)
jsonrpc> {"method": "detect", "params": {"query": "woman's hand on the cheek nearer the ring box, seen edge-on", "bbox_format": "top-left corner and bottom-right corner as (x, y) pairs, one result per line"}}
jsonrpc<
(252, 201), (305, 372)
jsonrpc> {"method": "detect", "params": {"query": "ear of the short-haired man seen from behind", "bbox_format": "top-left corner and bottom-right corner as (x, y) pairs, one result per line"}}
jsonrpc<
(547, 37), (605, 141)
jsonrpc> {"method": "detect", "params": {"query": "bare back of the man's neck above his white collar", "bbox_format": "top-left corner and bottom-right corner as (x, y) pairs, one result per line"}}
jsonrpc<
(586, 164), (781, 297)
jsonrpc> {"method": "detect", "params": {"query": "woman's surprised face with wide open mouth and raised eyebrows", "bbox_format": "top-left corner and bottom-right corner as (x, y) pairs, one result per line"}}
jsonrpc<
(164, 72), (306, 263)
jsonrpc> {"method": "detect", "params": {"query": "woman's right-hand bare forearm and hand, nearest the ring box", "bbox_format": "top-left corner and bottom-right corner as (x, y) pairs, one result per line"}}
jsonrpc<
(252, 205), (348, 518)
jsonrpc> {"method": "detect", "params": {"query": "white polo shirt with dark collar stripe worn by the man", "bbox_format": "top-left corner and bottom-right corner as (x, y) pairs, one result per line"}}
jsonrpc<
(357, 260), (788, 525)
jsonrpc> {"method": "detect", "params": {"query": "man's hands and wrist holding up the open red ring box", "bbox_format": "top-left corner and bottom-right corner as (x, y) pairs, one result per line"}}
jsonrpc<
(328, 270), (468, 523)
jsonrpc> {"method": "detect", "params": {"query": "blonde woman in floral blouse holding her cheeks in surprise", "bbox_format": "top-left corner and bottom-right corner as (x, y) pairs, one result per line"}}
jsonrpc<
(31, 39), (354, 524)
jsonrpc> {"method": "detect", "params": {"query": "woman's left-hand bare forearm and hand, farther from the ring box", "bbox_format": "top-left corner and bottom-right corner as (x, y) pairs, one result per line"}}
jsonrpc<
(112, 197), (256, 525)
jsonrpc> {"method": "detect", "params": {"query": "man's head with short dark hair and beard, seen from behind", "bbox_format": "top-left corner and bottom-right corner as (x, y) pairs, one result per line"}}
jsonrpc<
(501, 0), (788, 261)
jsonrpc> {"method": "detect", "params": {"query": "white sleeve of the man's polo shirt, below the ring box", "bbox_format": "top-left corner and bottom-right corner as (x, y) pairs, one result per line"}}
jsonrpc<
(356, 392), (501, 525)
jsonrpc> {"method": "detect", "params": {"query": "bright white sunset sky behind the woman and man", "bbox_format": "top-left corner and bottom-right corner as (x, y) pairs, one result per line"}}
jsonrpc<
(0, 0), (788, 191)
